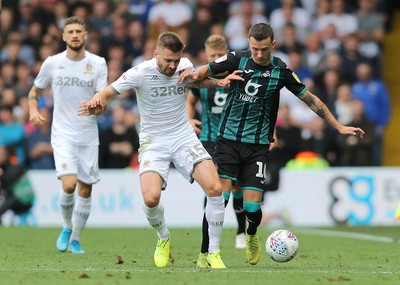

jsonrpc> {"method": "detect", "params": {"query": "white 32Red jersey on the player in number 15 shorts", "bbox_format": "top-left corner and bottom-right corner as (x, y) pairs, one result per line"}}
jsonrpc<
(111, 58), (194, 137)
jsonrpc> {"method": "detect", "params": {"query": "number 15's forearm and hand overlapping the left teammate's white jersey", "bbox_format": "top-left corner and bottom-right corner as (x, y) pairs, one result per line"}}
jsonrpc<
(78, 86), (116, 116)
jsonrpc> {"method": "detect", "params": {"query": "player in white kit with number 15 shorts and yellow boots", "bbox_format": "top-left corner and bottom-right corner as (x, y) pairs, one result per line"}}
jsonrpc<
(79, 32), (240, 268)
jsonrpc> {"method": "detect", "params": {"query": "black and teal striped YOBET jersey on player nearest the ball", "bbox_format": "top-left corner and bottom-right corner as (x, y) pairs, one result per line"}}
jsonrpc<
(208, 50), (306, 144)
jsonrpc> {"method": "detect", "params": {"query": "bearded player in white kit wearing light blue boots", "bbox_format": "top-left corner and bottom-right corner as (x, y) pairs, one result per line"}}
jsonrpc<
(28, 17), (107, 253)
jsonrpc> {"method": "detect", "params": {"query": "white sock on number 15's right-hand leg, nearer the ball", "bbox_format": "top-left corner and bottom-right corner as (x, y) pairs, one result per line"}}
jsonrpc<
(206, 195), (225, 253)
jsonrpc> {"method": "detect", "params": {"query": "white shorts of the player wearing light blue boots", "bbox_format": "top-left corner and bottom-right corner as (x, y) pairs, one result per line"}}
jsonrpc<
(52, 143), (100, 185)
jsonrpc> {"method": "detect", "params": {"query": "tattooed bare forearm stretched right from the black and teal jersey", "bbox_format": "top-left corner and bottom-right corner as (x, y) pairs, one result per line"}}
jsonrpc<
(299, 90), (365, 138)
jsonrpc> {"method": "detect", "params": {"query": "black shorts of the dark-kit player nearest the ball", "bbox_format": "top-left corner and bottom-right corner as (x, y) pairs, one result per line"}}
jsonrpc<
(214, 137), (269, 192)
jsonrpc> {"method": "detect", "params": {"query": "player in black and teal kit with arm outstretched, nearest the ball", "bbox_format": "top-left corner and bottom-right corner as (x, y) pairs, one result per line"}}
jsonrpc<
(179, 23), (364, 265)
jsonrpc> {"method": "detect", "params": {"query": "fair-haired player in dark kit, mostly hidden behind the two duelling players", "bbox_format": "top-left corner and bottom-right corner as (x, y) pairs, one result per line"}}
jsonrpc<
(186, 35), (246, 268)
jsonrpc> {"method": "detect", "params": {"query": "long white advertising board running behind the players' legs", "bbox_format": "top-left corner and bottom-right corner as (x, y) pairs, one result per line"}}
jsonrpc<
(4, 167), (400, 227)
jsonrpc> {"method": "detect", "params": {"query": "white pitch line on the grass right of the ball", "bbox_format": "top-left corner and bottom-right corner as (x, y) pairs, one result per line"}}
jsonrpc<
(296, 228), (399, 243)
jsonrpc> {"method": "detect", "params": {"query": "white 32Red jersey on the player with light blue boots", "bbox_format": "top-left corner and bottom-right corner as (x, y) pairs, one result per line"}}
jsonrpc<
(34, 51), (107, 145)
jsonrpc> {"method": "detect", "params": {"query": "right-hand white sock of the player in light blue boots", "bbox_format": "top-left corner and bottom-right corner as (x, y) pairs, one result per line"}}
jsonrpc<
(71, 195), (92, 240)
